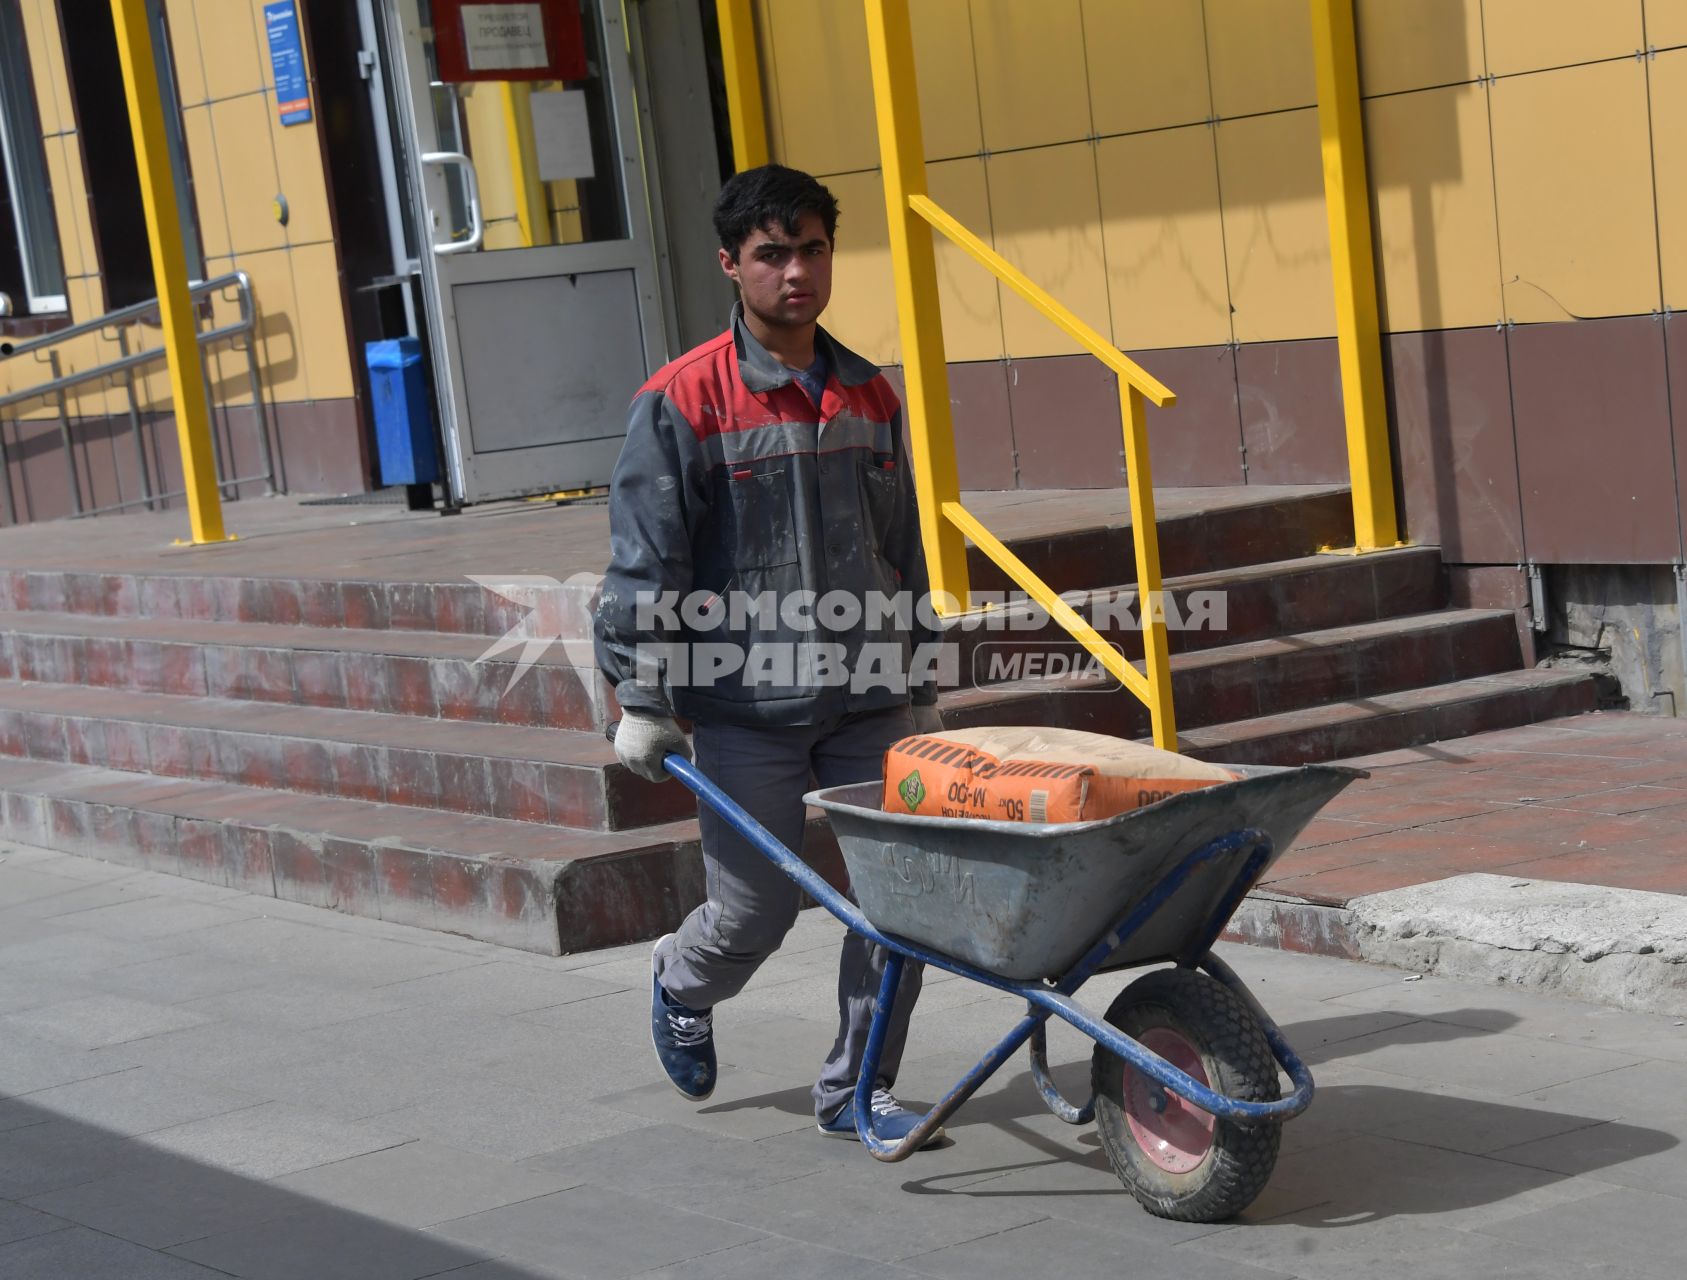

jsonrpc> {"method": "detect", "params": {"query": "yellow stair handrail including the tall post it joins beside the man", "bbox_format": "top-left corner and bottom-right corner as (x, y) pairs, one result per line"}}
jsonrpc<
(865, 0), (1178, 750)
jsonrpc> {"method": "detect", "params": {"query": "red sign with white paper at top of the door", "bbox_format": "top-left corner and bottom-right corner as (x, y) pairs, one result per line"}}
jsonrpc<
(434, 0), (585, 83)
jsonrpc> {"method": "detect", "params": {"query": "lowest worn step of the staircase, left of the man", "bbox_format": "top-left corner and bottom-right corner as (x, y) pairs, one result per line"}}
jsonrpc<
(0, 761), (705, 955)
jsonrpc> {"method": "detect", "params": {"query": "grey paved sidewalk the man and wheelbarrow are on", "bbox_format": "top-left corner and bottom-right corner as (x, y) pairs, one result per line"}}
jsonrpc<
(0, 836), (1687, 1280)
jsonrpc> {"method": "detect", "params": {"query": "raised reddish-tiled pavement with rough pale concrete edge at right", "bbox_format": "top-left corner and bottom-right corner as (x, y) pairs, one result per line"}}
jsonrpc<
(1232, 712), (1687, 1014)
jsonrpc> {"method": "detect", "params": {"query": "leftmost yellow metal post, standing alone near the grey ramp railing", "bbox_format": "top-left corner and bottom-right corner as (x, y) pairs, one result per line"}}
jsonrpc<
(111, 0), (226, 543)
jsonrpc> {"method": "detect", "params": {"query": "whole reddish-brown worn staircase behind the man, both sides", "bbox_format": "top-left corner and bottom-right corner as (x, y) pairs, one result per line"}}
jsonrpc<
(0, 489), (1596, 953)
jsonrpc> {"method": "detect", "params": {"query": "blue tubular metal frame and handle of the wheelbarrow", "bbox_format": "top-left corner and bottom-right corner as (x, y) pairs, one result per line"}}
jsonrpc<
(665, 754), (1363, 1162)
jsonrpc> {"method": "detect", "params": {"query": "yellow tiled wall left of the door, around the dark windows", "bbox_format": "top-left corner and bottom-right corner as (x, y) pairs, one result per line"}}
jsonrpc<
(0, 0), (353, 423)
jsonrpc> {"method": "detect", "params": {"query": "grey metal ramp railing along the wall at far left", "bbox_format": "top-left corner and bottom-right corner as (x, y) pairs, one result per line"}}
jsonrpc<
(0, 272), (275, 524)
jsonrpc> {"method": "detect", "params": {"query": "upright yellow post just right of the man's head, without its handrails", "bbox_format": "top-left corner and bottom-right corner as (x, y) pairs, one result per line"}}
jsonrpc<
(867, 0), (970, 614)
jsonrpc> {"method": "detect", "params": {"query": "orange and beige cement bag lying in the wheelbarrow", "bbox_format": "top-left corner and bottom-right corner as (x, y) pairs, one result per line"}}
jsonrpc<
(884, 725), (1237, 823)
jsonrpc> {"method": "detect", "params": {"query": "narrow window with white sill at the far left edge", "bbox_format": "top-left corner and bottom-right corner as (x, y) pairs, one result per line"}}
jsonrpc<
(0, 0), (64, 312)
